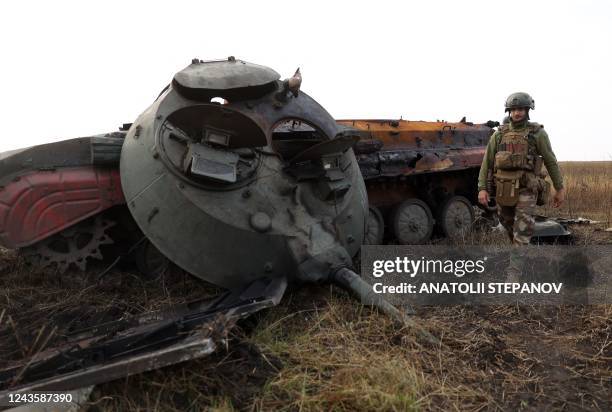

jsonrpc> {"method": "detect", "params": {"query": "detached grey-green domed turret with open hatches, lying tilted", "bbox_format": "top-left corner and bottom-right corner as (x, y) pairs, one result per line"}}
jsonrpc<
(120, 58), (367, 288)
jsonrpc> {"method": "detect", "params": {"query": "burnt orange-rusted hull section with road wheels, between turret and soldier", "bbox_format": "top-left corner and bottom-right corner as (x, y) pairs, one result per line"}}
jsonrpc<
(338, 118), (499, 244)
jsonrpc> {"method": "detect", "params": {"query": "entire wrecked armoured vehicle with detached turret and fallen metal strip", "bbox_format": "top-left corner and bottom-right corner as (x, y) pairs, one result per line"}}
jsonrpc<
(0, 57), (568, 400)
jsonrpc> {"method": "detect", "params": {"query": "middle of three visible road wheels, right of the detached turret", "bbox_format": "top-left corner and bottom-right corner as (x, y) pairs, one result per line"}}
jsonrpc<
(393, 199), (434, 245)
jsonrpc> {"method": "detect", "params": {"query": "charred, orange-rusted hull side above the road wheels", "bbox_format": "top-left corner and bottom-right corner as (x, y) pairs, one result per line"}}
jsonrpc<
(337, 119), (498, 212)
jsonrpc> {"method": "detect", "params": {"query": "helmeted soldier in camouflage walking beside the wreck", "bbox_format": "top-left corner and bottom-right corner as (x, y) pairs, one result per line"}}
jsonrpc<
(478, 93), (565, 246)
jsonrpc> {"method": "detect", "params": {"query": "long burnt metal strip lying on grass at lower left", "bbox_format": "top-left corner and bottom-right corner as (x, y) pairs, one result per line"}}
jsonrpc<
(0, 278), (287, 405)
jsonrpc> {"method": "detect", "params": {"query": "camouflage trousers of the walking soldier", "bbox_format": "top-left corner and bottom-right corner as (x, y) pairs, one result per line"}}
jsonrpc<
(497, 188), (538, 246)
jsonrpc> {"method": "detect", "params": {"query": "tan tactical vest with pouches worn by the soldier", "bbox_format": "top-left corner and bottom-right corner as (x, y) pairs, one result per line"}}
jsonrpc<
(494, 123), (545, 206)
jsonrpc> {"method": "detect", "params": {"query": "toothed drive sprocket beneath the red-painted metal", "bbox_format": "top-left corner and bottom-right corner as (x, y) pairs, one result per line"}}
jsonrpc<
(24, 216), (115, 273)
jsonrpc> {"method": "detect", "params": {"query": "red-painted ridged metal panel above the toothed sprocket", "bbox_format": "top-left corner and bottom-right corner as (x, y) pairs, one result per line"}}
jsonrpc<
(0, 166), (125, 249)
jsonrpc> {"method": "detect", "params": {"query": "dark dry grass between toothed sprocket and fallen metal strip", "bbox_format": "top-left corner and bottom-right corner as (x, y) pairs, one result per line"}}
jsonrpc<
(0, 258), (219, 368)
